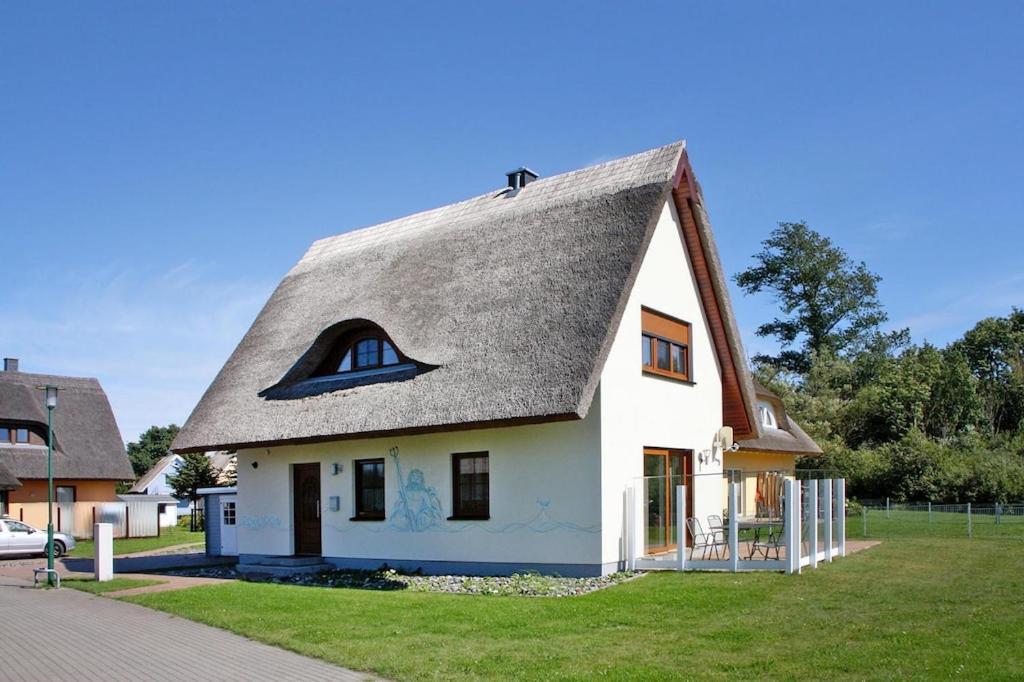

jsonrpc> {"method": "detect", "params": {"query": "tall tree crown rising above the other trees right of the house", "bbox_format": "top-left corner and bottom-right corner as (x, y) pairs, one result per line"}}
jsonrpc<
(735, 222), (888, 374)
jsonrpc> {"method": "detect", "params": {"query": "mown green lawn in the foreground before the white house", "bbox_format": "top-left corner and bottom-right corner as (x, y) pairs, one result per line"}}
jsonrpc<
(129, 539), (1024, 680)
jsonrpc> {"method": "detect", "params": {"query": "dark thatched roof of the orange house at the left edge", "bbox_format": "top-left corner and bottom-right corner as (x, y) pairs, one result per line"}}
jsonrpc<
(0, 372), (133, 480)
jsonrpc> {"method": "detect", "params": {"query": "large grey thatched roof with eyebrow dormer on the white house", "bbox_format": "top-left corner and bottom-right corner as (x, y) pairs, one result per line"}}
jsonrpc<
(173, 142), (815, 452)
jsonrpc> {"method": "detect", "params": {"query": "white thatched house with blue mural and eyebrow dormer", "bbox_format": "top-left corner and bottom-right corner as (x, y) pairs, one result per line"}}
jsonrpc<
(173, 142), (819, 576)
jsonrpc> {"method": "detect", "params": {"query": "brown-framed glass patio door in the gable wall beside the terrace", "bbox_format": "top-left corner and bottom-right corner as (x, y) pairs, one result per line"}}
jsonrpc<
(643, 447), (693, 553)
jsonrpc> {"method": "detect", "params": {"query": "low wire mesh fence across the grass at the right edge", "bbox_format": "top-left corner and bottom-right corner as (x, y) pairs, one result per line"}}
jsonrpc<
(848, 500), (1024, 540)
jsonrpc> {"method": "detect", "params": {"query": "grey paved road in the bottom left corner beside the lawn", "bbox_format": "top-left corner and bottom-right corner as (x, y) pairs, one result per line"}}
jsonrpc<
(0, 577), (372, 682)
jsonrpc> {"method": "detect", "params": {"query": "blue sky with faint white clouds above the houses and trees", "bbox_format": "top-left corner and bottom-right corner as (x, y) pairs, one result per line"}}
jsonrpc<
(0, 0), (1024, 440)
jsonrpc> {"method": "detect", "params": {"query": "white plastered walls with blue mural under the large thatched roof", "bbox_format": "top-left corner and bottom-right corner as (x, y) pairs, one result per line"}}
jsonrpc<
(238, 197), (722, 574)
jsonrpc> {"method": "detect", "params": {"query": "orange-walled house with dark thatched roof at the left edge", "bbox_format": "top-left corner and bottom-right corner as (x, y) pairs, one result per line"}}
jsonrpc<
(0, 357), (133, 535)
